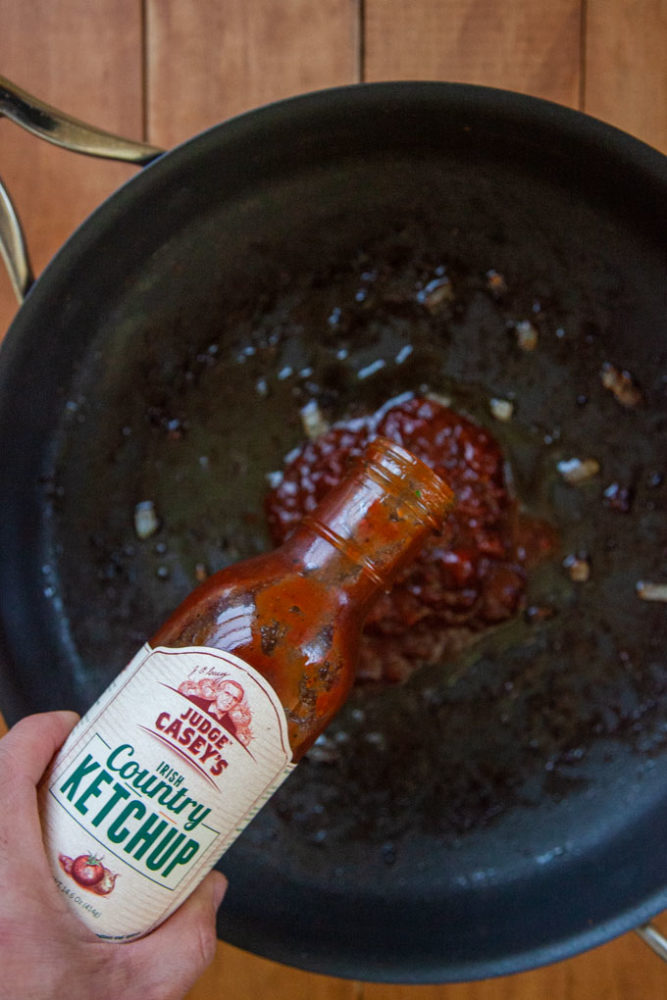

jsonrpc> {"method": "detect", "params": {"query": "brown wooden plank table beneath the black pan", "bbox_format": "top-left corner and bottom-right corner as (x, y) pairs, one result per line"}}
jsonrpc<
(0, 0), (667, 1000)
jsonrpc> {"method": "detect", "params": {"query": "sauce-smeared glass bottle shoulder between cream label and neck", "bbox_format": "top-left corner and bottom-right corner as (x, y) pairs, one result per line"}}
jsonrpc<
(151, 554), (361, 759)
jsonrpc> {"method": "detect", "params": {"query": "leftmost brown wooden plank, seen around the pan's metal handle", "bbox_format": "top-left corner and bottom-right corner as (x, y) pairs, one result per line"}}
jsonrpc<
(0, 0), (143, 332)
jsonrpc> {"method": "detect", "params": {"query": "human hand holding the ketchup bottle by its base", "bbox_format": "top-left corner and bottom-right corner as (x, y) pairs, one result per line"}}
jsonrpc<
(0, 712), (227, 1000)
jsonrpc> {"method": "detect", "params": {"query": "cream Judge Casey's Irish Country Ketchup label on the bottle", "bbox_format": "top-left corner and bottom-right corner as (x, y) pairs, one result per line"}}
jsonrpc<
(40, 645), (294, 941)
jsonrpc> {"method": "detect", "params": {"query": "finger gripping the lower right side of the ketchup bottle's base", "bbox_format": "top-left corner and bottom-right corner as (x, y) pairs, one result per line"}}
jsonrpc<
(123, 870), (227, 1000)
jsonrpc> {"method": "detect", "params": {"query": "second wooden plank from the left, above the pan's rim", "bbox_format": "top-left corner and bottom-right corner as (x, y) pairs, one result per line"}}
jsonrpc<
(146, 0), (359, 146)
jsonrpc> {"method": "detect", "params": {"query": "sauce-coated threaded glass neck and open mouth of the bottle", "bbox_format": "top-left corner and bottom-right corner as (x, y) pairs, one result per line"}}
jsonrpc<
(282, 438), (453, 605)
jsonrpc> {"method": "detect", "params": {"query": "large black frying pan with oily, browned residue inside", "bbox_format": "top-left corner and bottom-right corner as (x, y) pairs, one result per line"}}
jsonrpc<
(0, 84), (667, 983)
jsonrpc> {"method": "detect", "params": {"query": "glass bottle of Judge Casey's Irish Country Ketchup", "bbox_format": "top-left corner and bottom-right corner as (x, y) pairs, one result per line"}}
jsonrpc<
(40, 438), (453, 941)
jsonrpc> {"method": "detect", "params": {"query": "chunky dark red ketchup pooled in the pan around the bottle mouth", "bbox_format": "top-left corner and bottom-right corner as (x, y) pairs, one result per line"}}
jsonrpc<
(266, 398), (554, 683)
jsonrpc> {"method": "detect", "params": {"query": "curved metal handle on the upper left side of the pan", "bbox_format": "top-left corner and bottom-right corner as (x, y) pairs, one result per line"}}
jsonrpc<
(0, 76), (164, 303)
